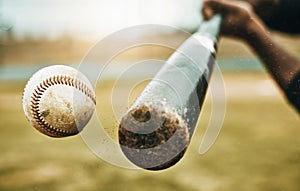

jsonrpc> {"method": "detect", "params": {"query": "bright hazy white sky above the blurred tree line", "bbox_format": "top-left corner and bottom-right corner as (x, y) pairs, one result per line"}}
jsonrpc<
(0, 0), (201, 40)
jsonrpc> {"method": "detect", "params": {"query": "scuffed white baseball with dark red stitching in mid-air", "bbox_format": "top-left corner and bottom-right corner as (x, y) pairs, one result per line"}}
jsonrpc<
(22, 65), (96, 137)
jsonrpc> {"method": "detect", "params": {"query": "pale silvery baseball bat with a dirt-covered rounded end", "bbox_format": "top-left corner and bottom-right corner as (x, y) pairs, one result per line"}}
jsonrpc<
(118, 15), (222, 170)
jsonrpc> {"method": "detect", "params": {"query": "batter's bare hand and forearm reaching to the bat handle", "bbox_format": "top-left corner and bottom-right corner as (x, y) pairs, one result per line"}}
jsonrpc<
(202, 0), (300, 110)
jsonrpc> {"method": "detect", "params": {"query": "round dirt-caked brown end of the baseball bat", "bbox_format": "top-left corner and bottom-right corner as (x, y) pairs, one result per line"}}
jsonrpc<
(119, 104), (190, 170)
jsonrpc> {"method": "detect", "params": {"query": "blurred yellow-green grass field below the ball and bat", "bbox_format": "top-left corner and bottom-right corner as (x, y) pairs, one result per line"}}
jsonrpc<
(0, 73), (300, 191)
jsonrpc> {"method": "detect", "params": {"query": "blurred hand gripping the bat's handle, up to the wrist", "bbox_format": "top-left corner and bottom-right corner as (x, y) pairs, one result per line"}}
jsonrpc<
(202, 0), (264, 40)
